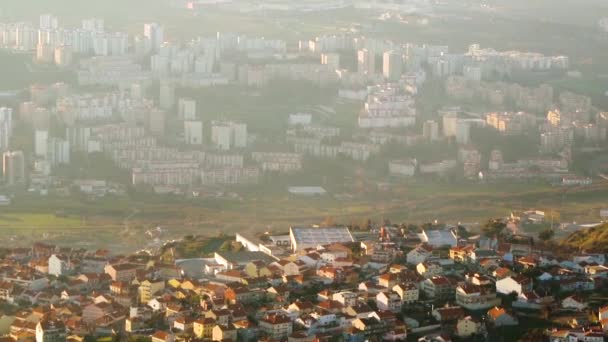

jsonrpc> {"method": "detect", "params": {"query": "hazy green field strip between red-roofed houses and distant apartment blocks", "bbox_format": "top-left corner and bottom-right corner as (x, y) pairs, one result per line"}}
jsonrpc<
(0, 181), (608, 250)
